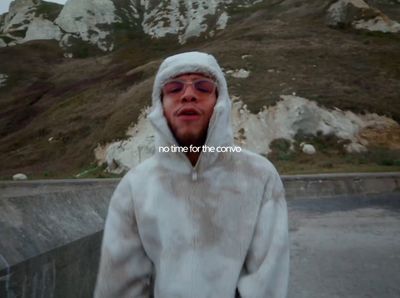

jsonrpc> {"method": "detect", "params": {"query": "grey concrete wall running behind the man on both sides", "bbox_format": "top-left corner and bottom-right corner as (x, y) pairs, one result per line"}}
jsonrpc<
(0, 173), (400, 298)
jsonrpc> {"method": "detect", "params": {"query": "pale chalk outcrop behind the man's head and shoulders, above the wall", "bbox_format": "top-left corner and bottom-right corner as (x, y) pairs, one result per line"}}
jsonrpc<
(95, 95), (400, 173)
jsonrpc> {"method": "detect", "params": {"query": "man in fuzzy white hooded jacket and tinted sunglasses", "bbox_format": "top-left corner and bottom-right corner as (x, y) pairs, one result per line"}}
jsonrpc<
(95, 52), (289, 298)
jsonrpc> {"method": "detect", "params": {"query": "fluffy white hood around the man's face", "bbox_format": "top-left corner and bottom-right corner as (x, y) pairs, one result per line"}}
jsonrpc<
(148, 52), (233, 173)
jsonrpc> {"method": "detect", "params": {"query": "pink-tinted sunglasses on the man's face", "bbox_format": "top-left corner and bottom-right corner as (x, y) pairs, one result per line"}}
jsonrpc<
(162, 79), (217, 95)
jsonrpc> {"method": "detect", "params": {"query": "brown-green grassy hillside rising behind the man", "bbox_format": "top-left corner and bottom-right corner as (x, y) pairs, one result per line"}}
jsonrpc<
(0, 1), (400, 178)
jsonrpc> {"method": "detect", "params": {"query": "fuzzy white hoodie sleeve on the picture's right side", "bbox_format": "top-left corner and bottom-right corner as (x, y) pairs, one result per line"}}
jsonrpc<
(237, 172), (289, 298)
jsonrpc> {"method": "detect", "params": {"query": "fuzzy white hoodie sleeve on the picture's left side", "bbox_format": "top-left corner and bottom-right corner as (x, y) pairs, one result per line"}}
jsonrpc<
(94, 174), (152, 298)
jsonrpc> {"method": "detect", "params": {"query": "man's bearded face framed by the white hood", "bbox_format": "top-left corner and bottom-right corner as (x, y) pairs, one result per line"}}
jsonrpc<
(162, 73), (217, 146)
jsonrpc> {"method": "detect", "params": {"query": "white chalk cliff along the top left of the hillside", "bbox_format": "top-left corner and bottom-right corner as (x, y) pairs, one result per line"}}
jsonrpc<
(0, 0), (261, 51)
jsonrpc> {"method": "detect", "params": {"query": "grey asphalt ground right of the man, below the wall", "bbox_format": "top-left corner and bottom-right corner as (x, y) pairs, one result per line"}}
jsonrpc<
(288, 193), (400, 298)
